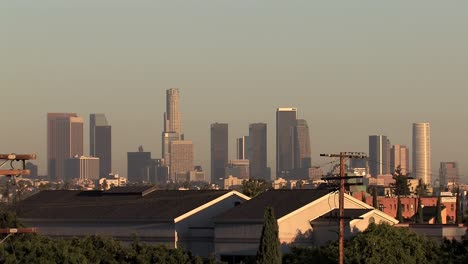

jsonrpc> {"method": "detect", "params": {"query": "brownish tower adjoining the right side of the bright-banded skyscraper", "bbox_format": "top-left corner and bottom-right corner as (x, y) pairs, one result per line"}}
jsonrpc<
(294, 119), (312, 179)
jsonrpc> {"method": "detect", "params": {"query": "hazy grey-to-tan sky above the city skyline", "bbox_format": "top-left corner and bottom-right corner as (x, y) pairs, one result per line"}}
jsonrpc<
(0, 0), (468, 179)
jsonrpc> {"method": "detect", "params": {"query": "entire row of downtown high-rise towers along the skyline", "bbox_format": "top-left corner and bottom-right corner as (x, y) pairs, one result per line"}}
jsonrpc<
(47, 88), (459, 189)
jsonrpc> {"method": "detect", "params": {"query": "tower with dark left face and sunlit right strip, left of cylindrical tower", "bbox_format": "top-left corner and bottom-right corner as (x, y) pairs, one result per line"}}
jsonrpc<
(369, 135), (390, 177)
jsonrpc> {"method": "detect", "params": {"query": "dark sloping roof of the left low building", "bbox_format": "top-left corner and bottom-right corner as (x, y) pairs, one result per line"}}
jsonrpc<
(18, 189), (229, 221)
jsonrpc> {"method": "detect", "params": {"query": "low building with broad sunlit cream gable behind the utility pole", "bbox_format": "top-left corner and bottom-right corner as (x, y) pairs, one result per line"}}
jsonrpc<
(215, 190), (398, 263)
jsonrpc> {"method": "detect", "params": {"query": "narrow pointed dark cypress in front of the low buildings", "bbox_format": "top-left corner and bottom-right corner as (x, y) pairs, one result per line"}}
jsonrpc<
(256, 207), (281, 264)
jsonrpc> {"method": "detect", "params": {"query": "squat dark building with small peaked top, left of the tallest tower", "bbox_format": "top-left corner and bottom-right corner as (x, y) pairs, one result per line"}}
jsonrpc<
(127, 146), (152, 183)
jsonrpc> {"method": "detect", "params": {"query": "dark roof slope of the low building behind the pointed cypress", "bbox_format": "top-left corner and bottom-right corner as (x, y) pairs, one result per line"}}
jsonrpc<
(215, 190), (330, 222)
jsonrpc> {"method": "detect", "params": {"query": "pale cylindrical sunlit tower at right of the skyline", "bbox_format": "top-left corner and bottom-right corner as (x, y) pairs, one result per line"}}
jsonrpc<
(413, 123), (434, 185)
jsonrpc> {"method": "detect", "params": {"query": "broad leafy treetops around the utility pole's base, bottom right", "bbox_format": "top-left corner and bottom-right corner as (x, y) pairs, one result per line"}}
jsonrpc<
(284, 224), (444, 264)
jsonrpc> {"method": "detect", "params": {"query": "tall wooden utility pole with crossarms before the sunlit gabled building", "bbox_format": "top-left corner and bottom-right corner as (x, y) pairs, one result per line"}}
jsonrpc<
(320, 152), (367, 264)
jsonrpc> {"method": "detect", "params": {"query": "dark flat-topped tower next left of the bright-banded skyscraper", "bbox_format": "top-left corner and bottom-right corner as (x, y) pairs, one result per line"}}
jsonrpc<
(248, 123), (271, 181)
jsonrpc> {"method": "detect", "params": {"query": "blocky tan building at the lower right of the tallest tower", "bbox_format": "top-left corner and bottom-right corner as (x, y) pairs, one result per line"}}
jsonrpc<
(169, 140), (194, 182)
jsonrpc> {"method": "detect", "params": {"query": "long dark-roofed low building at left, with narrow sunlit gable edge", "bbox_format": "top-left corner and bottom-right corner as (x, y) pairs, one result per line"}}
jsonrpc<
(19, 187), (250, 257)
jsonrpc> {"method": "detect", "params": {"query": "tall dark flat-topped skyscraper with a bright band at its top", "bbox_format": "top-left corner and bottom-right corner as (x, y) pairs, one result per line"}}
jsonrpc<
(276, 108), (297, 179)
